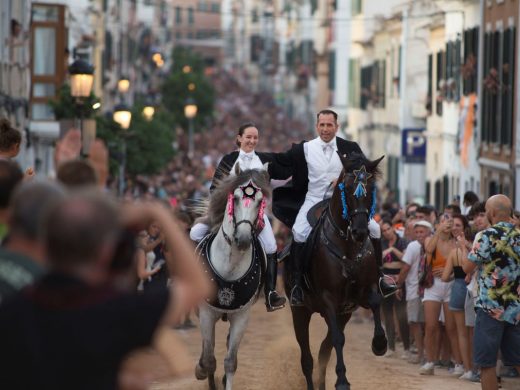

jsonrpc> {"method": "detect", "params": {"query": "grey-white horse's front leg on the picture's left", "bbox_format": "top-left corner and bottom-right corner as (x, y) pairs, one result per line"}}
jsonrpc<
(195, 306), (220, 390)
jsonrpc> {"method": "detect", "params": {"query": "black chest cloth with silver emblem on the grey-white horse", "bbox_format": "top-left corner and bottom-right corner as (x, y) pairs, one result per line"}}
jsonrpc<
(196, 233), (265, 312)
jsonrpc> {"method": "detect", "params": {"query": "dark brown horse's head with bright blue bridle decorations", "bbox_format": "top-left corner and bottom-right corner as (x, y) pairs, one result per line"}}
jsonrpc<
(336, 153), (384, 242)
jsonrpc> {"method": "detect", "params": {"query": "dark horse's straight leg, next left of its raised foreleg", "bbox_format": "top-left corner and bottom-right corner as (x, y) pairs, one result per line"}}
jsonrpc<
(323, 293), (350, 390)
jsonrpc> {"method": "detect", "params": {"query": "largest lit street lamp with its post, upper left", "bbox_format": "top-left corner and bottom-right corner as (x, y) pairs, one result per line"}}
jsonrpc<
(69, 59), (96, 157)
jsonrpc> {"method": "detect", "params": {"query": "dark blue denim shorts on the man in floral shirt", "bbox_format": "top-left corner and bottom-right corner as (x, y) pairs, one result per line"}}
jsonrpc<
(473, 309), (520, 368)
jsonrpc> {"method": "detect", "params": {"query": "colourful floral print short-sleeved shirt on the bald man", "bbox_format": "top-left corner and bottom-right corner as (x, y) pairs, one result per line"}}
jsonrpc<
(468, 222), (520, 325)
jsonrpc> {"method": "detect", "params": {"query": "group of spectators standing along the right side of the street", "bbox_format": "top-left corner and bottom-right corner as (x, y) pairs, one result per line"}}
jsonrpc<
(379, 192), (520, 389)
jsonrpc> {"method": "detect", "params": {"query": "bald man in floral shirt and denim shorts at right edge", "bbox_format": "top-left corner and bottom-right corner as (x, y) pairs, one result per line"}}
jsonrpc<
(462, 195), (520, 390)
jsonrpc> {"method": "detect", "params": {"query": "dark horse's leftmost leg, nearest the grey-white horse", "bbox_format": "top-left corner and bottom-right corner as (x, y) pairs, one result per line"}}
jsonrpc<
(291, 306), (314, 390)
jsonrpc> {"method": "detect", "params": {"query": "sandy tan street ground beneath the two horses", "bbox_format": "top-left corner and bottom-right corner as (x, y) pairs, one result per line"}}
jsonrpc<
(127, 301), (520, 390)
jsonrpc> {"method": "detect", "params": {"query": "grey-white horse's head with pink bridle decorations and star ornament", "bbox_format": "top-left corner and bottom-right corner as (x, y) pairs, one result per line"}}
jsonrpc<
(209, 163), (270, 250)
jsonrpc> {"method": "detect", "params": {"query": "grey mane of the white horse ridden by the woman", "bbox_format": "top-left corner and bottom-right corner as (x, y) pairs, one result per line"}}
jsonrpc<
(207, 169), (271, 231)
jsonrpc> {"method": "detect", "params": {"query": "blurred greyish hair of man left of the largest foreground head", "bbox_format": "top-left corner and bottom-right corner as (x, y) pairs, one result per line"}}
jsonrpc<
(9, 179), (65, 240)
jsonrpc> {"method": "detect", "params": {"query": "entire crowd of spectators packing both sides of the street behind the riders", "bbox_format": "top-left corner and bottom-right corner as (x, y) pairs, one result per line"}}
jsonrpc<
(0, 67), (520, 389)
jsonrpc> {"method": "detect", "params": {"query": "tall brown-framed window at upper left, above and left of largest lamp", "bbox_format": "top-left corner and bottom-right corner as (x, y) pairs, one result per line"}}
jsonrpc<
(30, 3), (67, 120)
